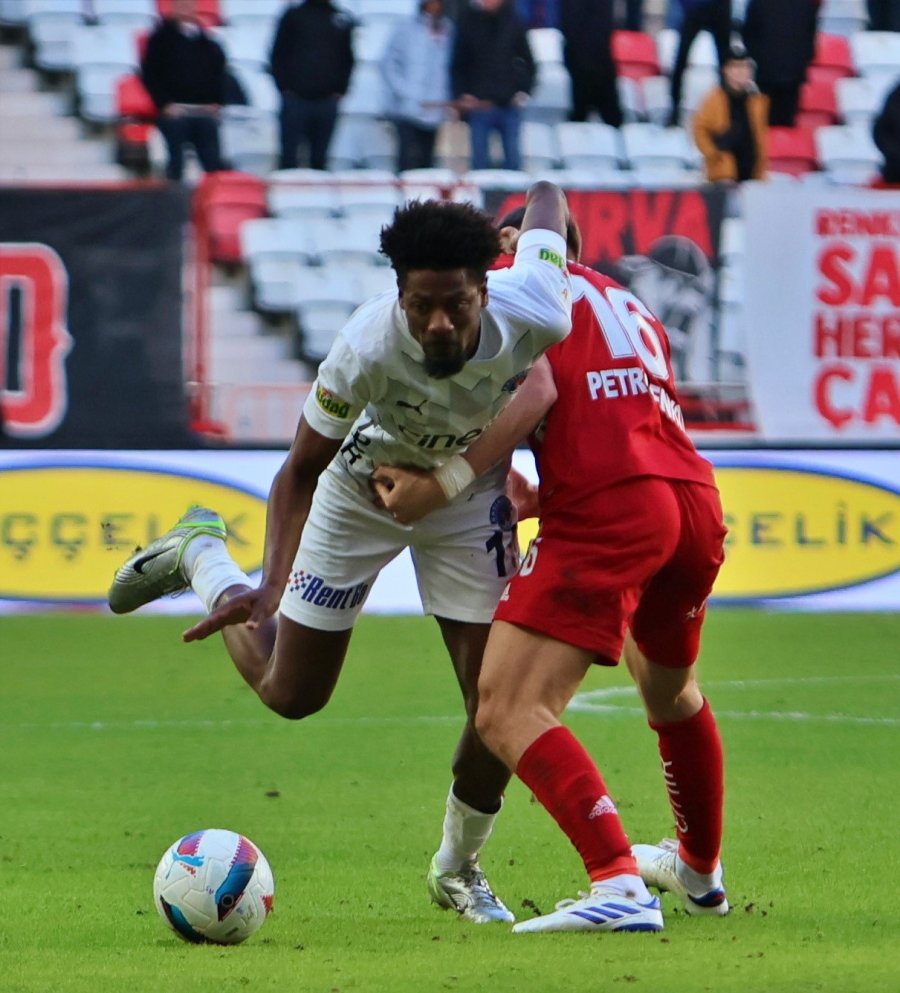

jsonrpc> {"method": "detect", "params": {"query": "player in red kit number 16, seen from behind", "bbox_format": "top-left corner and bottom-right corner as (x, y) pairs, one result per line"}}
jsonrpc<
(373, 217), (728, 933)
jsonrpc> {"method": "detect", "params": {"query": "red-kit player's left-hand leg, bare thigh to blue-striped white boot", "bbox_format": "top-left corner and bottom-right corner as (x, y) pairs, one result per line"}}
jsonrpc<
(477, 620), (663, 933)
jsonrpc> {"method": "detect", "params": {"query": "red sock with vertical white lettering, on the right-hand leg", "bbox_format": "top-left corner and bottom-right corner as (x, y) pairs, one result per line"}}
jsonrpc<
(650, 700), (724, 872)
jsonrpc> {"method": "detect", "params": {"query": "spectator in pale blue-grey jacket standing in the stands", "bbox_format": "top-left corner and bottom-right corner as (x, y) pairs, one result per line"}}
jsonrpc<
(381, 0), (453, 172)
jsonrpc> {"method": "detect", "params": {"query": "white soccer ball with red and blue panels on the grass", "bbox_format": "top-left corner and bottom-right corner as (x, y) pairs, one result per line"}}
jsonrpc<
(153, 828), (275, 945)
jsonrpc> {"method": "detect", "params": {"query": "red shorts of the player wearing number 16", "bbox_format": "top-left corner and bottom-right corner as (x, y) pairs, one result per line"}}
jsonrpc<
(494, 477), (726, 668)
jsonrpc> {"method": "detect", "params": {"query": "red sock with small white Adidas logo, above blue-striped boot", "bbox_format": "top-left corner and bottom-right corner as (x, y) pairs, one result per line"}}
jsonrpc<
(516, 726), (638, 882)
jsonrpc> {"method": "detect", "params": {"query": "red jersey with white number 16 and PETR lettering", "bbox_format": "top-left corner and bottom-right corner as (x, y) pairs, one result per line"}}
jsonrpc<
(532, 262), (715, 534)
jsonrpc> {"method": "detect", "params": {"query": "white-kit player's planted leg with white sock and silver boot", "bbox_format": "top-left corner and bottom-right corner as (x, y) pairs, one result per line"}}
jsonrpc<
(428, 617), (515, 924)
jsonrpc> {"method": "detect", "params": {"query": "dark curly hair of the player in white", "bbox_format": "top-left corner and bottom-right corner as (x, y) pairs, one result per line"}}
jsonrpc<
(381, 200), (500, 282)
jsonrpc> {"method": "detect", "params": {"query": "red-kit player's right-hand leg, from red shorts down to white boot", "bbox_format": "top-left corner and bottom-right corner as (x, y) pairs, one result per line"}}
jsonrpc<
(625, 484), (728, 915)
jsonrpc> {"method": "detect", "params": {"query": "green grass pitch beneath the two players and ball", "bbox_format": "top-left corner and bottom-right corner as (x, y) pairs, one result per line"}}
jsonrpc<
(0, 610), (900, 993)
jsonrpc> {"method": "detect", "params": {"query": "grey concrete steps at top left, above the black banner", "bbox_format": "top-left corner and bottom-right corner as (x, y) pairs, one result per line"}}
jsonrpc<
(0, 39), (130, 183)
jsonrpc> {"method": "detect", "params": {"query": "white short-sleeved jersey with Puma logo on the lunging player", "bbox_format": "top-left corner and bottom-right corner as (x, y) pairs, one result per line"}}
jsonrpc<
(303, 229), (572, 485)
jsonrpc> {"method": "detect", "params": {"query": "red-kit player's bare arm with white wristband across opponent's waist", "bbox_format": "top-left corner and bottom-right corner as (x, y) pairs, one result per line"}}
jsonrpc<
(372, 358), (557, 524)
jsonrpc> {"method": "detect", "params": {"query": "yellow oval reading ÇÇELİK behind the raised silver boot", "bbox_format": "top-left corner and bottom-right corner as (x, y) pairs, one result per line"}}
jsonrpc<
(0, 465), (268, 601)
